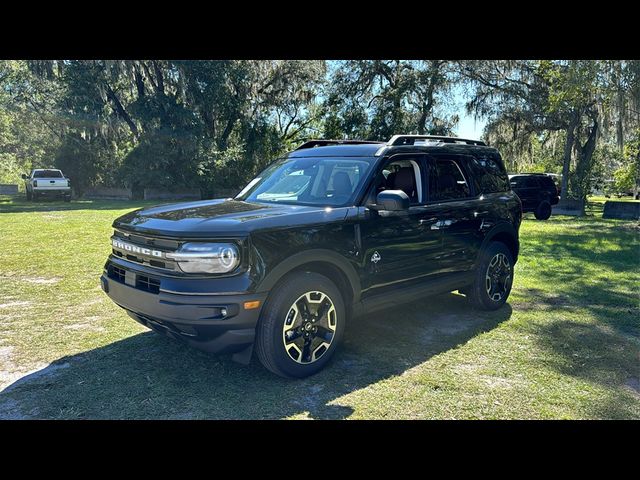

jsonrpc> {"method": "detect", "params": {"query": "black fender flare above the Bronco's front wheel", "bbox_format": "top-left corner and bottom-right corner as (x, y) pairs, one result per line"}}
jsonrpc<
(256, 248), (362, 302)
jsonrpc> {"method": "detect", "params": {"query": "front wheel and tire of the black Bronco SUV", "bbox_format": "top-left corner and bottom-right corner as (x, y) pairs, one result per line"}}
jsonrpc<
(255, 272), (346, 378)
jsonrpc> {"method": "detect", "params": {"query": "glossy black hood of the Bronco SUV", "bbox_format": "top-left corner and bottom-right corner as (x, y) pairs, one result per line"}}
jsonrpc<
(113, 199), (349, 238)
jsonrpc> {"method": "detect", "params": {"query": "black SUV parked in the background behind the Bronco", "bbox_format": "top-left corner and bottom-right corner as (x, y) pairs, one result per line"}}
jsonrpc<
(509, 173), (560, 220)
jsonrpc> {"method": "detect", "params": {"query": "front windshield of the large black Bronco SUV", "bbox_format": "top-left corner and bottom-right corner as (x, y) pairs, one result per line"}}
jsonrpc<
(236, 157), (371, 207)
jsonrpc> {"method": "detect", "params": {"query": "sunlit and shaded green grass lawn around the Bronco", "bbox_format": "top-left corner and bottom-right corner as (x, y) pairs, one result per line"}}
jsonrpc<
(0, 193), (640, 419)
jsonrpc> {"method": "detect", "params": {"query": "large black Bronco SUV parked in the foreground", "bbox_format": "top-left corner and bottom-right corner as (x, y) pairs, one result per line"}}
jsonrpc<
(101, 135), (522, 377)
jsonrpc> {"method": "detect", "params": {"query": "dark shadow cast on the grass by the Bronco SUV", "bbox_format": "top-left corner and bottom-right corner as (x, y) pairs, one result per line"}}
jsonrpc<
(0, 293), (512, 419)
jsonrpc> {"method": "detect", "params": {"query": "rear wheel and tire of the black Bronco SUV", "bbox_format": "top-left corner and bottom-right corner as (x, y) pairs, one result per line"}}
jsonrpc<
(465, 242), (513, 310)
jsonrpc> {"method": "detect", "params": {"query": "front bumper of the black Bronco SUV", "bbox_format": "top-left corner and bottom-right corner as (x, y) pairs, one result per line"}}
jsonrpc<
(100, 262), (267, 361)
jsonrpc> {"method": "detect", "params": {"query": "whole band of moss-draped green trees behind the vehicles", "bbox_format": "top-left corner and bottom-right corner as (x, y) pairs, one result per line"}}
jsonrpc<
(0, 60), (640, 197)
